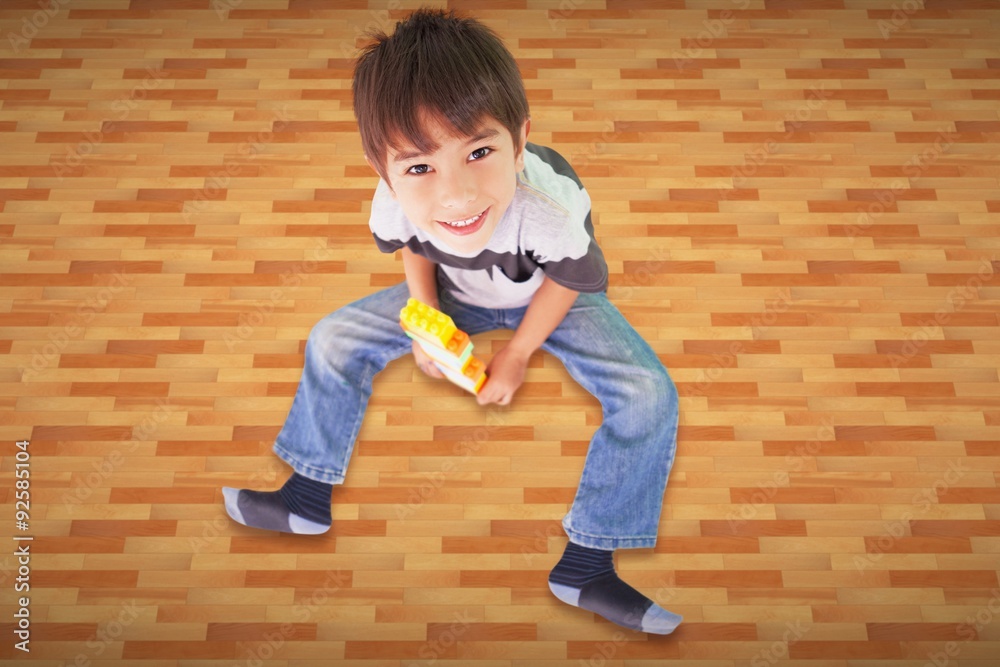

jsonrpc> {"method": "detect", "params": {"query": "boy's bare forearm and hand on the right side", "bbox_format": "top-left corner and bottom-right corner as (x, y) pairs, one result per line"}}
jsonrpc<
(477, 276), (580, 405)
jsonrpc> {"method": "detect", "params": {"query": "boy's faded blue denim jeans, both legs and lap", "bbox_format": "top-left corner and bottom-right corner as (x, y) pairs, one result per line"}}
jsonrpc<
(274, 283), (677, 549)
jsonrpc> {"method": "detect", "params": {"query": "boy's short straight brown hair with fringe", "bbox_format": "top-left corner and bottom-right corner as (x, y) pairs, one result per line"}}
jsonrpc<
(353, 8), (528, 183)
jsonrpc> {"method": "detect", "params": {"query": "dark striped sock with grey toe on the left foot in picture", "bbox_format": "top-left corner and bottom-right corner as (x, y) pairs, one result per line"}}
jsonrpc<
(222, 473), (333, 535)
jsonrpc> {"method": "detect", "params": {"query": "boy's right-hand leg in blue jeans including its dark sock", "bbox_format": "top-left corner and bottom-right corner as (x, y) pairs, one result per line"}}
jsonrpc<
(524, 294), (681, 634)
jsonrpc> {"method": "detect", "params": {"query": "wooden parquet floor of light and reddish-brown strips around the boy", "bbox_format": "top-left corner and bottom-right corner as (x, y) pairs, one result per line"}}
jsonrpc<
(0, 0), (1000, 667)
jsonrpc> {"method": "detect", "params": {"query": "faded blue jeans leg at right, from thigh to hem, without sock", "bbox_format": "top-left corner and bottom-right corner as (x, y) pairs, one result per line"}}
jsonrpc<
(542, 294), (678, 549)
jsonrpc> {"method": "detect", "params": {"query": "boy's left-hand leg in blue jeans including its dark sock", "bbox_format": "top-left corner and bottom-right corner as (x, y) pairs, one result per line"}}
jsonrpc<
(223, 283), (411, 534)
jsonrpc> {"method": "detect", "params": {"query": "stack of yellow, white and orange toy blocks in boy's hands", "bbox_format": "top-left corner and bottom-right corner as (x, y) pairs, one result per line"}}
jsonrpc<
(399, 298), (486, 394)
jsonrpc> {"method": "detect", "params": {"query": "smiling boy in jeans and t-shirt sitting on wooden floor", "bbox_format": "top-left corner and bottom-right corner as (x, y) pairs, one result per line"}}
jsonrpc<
(223, 9), (681, 634)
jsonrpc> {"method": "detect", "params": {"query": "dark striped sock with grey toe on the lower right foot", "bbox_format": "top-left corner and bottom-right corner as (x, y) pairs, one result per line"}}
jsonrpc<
(549, 542), (682, 635)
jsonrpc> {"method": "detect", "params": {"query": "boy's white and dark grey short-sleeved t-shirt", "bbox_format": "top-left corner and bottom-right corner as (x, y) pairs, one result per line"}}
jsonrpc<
(368, 143), (608, 308)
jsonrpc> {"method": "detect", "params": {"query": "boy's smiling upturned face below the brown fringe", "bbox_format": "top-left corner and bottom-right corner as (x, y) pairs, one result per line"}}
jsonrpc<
(376, 115), (531, 253)
